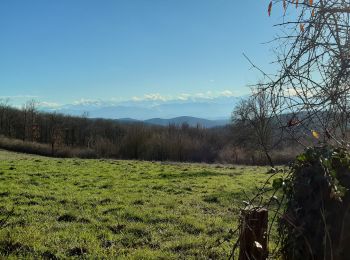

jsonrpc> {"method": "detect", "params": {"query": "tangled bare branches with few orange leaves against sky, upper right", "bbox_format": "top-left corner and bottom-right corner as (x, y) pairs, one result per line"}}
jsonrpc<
(254, 0), (350, 146)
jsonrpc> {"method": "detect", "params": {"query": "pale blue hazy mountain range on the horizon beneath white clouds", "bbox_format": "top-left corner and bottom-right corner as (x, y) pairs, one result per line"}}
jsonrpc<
(42, 96), (244, 120)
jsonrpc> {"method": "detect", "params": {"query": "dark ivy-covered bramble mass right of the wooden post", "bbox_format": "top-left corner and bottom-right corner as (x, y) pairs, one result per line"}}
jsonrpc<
(274, 146), (350, 259)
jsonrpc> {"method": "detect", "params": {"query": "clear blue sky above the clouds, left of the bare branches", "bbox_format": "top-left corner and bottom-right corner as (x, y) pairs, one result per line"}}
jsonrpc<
(0, 0), (277, 104)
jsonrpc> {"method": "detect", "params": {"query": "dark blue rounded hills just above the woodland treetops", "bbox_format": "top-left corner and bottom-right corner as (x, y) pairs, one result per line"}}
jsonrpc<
(117, 116), (230, 128)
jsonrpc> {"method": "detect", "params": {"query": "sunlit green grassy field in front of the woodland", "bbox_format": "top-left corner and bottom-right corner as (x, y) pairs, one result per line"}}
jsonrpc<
(0, 151), (274, 259)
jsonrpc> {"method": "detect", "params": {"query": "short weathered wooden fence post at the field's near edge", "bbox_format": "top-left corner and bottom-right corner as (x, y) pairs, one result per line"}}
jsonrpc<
(239, 206), (268, 260)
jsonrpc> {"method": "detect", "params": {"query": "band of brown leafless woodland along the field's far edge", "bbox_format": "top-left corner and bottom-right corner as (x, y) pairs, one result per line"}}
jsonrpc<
(0, 101), (301, 165)
